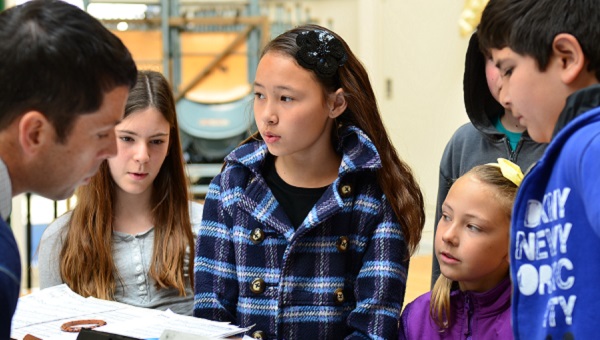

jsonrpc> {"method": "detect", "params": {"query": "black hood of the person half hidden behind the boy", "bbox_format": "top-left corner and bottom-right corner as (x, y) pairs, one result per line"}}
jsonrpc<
(463, 32), (504, 136)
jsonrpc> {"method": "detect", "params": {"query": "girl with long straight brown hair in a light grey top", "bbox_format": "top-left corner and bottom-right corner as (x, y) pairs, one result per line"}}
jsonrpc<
(39, 71), (202, 314)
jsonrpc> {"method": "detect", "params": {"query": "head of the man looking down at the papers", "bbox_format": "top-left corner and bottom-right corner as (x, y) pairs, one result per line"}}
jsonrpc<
(0, 0), (137, 199)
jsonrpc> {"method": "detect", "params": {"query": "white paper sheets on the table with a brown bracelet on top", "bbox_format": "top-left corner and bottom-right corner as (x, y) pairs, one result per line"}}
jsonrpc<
(11, 284), (247, 340)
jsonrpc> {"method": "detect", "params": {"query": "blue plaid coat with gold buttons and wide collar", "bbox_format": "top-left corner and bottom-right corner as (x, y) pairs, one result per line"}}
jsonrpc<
(194, 127), (408, 339)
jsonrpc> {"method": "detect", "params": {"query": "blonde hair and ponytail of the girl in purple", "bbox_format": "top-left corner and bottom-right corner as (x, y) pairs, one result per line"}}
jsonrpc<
(429, 164), (518, 332)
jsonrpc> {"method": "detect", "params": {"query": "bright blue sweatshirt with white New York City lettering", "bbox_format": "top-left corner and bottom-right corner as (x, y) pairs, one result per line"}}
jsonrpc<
(510, 85), (600, 339)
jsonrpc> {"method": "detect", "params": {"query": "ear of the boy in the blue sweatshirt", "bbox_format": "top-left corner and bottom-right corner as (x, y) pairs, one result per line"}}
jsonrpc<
(552, 33), (586, 84)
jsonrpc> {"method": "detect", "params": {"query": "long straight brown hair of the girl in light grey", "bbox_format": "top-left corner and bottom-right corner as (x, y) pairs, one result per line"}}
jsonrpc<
(60, 71), (194, 300)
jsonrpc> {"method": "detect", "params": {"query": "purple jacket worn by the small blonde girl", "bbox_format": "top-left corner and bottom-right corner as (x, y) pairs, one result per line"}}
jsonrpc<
(399, 278), (513, 340)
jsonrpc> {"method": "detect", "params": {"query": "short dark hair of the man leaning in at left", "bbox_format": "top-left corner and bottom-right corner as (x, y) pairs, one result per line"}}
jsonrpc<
(0, 0), (137, 142)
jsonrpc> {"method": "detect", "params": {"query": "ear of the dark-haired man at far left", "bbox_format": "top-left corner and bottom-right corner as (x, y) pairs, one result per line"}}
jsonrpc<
(19, 111), (54, 154)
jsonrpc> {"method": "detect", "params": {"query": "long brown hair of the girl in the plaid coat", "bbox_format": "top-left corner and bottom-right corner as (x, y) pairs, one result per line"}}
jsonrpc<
(246, 25), (425, 256)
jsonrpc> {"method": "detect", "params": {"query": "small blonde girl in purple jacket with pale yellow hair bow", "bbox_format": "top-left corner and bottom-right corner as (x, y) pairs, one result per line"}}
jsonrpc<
(399, 158), (523, 340)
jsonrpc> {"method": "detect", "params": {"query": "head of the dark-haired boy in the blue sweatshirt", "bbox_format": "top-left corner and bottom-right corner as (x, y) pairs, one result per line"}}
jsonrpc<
(477, 0), (600, 142)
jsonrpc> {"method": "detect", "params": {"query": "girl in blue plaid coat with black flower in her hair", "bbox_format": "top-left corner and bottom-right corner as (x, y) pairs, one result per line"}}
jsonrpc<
(194, 25), (425, 339)
